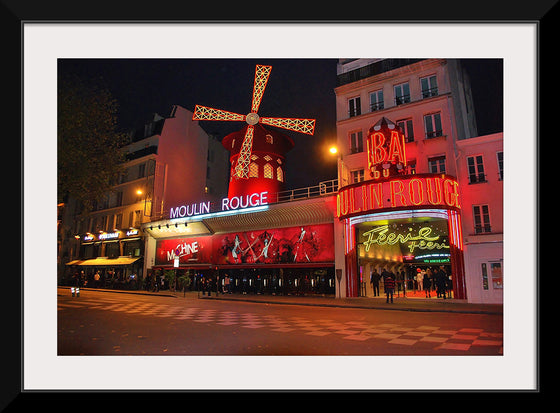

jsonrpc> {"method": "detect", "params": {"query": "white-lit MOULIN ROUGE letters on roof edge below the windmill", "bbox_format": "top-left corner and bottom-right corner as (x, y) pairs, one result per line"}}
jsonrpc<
(169, 191), (268, 219)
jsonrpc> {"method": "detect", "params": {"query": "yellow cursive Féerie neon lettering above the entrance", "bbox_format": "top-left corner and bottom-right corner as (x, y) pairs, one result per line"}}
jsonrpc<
(363, 225), (449, 253)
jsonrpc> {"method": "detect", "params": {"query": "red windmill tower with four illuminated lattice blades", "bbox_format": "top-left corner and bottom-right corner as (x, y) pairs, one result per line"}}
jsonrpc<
(193, 65), (315, 198)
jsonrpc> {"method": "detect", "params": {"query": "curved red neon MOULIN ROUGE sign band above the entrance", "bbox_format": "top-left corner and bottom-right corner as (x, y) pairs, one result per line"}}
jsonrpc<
(336, 174), (461, 219)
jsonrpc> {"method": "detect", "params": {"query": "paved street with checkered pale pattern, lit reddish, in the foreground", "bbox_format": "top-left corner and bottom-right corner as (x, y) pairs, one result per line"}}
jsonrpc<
(58, 289), (503, 356)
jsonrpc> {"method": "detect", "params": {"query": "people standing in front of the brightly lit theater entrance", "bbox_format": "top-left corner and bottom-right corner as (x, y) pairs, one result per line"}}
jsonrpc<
(370, 265), (451, 303)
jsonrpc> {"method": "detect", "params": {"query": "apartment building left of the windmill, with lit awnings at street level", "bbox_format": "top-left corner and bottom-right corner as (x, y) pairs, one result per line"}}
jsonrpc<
(63, 105), (229, 288)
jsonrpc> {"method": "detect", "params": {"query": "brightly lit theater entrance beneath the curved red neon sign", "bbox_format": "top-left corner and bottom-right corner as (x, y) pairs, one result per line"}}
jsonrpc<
(347, 211), (463, 299)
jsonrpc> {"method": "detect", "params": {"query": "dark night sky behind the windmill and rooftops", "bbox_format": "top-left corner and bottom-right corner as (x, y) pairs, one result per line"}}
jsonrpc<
(58, 59), (503, 189)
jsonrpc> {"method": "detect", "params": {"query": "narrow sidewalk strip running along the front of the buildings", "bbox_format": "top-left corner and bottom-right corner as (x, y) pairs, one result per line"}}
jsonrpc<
(58, 286), (503, 315)
